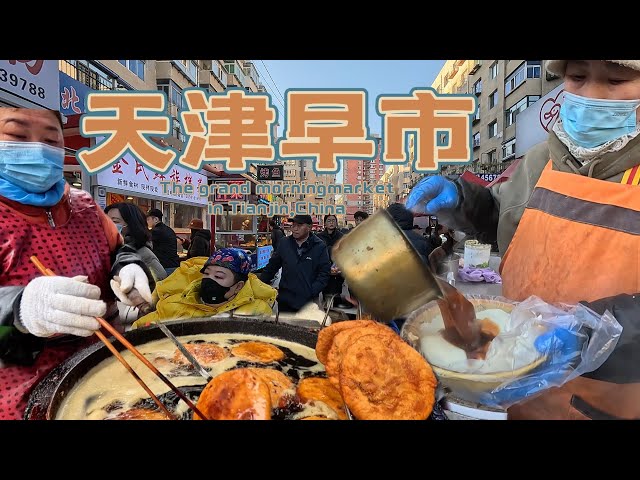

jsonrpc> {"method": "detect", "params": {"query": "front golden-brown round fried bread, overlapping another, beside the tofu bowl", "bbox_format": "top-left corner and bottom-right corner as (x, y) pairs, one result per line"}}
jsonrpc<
(340, 334), (437, 420)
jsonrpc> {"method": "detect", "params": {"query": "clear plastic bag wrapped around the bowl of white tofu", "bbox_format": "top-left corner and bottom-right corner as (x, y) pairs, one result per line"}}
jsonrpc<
(402, 296), (622, 408)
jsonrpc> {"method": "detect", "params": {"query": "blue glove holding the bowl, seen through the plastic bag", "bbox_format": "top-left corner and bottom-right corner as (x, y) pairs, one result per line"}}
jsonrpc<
(480, 328), (586, 407)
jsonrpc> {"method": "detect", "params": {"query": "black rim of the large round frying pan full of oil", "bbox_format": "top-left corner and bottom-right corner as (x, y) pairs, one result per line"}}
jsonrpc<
(24, 319), (318, 420)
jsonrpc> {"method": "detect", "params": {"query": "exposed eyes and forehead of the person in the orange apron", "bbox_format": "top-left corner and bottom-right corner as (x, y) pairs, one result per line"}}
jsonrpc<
(564, 60), (640, 103)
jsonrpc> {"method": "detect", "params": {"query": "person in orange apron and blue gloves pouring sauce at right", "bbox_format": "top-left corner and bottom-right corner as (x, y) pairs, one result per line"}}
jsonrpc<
(406, 60), (640, 419)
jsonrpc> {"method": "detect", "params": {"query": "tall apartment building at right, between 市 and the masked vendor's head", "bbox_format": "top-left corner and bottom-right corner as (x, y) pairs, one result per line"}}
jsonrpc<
(432, 60), (561, 174)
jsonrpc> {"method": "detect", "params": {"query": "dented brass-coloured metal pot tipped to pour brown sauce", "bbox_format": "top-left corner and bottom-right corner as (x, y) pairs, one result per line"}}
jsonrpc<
(331, 210), (444, 322)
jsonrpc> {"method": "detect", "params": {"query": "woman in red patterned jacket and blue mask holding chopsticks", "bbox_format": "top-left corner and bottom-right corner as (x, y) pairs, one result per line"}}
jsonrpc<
(0, 108), (153, 419)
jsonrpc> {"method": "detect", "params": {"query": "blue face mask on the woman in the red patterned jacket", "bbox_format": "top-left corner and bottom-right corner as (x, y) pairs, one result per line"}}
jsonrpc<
(0, 141), (64, 193)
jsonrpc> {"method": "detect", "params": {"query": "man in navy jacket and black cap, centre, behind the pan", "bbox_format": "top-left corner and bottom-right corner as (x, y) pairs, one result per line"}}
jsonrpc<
(260, 215), (331, 312)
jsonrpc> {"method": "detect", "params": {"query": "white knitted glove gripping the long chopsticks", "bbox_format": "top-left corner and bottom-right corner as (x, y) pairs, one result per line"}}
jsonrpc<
(20, 276), (107, 337)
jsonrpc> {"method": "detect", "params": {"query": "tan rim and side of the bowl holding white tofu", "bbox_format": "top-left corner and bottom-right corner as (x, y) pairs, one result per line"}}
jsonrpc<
(401, 295), (546, 401)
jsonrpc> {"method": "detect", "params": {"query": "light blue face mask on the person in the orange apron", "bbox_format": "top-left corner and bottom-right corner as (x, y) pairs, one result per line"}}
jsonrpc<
(560, 92), (640, 148)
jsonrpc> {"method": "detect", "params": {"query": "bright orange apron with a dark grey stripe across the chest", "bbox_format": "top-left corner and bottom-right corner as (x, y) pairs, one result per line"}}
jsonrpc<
(500, 160), (640, 304)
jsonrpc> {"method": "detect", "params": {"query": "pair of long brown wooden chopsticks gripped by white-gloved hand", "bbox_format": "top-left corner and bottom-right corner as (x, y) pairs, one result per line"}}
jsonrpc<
(30, 255), (208, 420)
